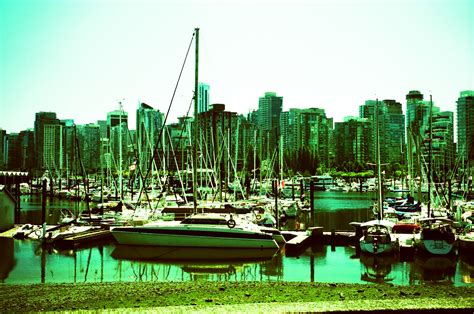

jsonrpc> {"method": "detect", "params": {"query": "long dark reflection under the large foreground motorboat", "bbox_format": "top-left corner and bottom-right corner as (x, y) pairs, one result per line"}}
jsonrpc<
(112, 245), (278, 264)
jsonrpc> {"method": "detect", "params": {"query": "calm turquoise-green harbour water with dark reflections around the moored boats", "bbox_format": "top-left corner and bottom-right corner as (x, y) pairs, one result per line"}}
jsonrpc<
(0, 192), (474, 286)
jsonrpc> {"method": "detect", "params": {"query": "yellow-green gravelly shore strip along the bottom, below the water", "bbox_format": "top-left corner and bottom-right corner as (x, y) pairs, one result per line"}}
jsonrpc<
(0, 282), (474, 313)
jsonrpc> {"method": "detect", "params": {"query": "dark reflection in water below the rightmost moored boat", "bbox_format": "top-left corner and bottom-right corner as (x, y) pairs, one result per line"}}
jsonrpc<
(414, 255), (456, 284)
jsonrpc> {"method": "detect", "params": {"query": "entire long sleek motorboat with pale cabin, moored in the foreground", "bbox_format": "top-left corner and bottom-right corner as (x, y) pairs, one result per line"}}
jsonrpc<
(111, 214), (278, 249)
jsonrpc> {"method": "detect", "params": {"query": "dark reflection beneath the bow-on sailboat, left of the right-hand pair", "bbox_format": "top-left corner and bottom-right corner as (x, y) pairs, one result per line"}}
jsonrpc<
(360, 254), (396, 283)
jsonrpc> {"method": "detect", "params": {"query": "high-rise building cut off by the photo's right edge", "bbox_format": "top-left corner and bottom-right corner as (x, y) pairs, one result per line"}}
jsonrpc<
(456, 90), (474, 163)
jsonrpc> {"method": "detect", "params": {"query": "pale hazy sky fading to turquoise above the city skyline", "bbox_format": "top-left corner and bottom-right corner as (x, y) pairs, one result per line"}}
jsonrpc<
(0, 0), (474, 133)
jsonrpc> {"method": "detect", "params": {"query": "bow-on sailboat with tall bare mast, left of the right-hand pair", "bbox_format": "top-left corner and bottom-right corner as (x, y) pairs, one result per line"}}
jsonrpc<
(359, 99), (399, 255)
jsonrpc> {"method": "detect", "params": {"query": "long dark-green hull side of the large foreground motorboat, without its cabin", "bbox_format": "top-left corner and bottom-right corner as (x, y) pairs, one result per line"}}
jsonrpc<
(111, 227), (278, 249)
